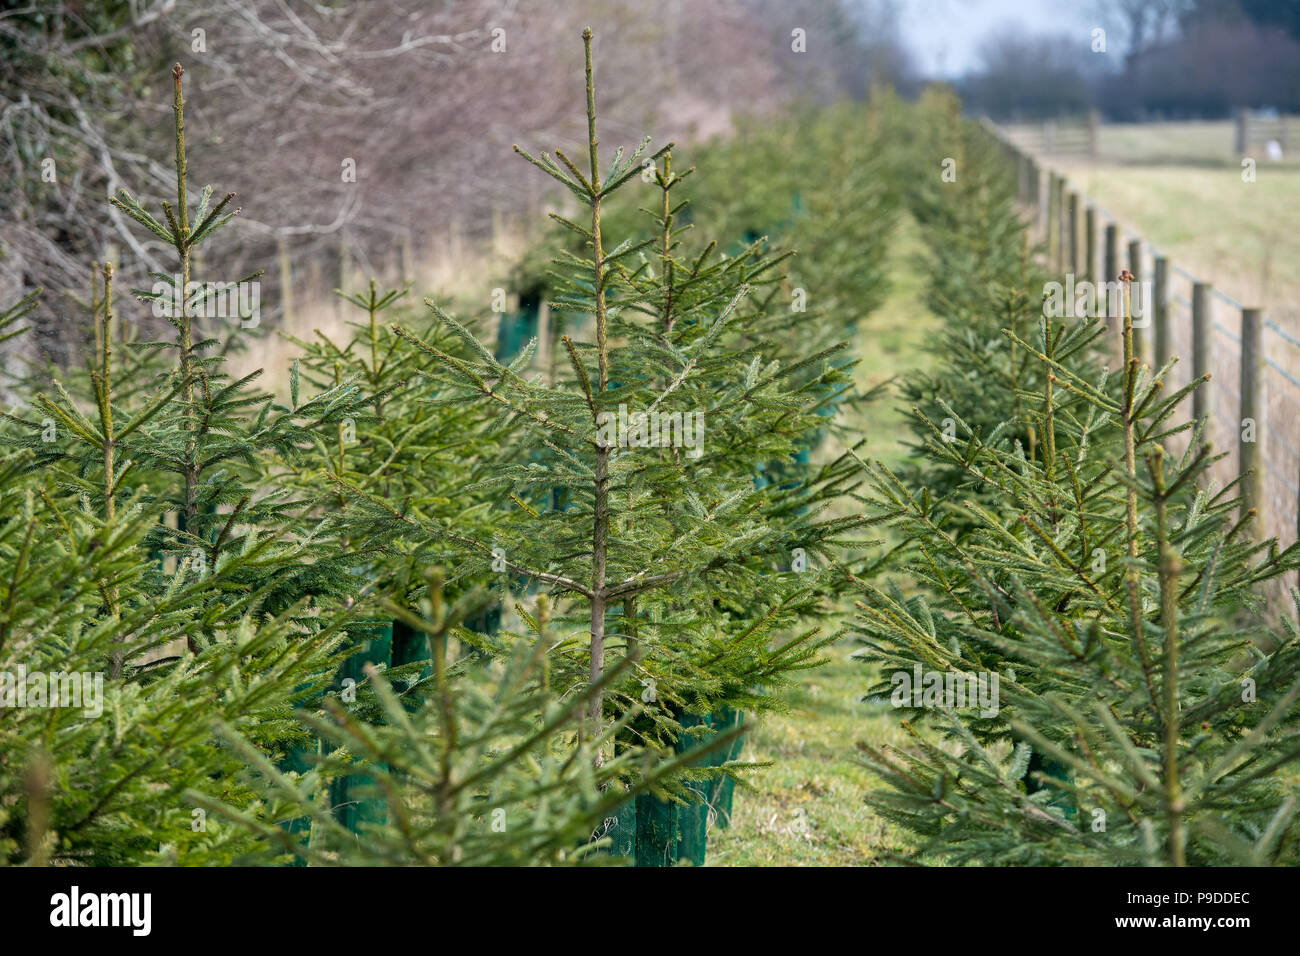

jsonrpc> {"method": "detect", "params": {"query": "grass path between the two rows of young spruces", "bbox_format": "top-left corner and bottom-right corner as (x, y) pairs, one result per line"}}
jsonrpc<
(709, 213), (939, 866)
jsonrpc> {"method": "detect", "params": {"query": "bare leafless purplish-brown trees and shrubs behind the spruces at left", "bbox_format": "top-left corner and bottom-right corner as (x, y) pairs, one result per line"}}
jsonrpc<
(0, 0), (883, 355)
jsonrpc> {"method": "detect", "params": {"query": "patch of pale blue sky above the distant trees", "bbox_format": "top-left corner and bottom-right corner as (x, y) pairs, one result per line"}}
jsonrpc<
(900, 0), (1102, 77)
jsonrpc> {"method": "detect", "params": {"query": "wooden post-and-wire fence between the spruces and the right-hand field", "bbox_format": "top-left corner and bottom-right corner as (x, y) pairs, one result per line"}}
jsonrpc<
(984, 122), (1300, 597)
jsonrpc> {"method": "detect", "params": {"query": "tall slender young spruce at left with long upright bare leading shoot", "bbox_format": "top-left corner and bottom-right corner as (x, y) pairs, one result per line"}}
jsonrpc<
(94, 64), (364, 621)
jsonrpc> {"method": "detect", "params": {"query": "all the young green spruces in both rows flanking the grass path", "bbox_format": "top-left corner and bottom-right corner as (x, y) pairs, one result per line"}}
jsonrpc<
(10, 34), (1300, 865)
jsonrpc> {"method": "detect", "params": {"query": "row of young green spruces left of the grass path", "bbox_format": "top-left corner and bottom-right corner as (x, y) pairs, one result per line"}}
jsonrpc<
(0, 34), (889, 865)
